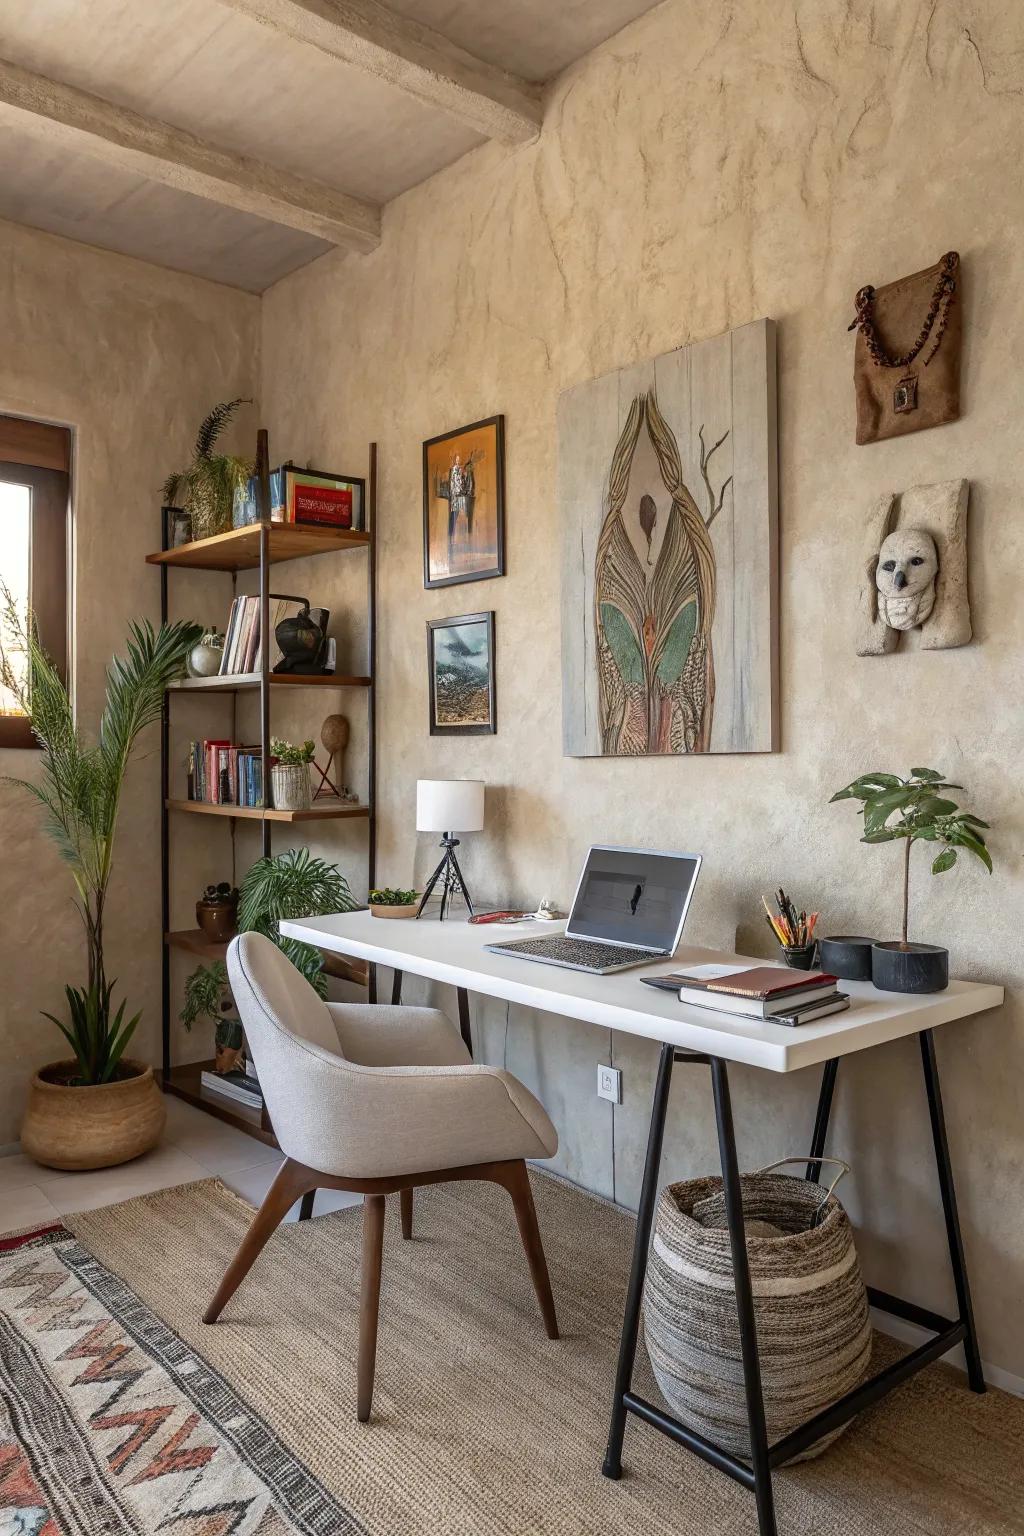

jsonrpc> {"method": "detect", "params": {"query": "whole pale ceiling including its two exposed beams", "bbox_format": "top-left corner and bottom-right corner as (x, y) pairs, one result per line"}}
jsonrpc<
(0, 0), (654, 292)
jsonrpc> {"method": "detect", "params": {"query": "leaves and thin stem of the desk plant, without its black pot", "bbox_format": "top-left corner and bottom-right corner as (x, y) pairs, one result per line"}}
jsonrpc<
(829, 768), (992, 948)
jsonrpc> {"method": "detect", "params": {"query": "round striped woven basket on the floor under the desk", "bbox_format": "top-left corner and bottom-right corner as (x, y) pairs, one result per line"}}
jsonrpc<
(643, 1157), (870, 1461)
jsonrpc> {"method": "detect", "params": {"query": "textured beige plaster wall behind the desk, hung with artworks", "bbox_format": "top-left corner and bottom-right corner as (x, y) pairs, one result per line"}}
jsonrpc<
(263, 0), (1024, 1373)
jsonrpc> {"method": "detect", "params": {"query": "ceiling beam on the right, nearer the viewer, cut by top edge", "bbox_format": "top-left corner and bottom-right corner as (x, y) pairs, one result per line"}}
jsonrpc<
(224, 0), (542, 144)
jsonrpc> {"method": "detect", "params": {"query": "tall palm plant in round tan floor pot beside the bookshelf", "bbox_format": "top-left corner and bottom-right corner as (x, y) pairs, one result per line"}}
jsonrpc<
(0, 588), (201, 1169)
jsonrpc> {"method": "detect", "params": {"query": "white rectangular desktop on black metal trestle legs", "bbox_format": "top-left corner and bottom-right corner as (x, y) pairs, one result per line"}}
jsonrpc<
(281, 911), (1003, 1072)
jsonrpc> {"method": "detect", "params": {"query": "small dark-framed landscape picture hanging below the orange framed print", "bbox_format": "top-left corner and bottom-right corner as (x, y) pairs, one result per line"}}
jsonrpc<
(427, 611), (497, 736)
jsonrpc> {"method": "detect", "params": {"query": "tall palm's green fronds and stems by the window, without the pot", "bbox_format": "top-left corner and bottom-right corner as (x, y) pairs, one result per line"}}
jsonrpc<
(0, 584), (201, 1084)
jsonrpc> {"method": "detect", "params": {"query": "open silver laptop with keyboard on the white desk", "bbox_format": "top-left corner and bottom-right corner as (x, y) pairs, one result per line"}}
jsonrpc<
(484, 848), (702, 975)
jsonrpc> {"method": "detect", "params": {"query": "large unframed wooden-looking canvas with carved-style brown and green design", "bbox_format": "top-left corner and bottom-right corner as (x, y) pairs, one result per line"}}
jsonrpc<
(559, 319), (778, 757)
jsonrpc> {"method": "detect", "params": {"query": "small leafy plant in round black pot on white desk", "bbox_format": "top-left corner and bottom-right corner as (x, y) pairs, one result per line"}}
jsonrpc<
(829, 768), (992, 992)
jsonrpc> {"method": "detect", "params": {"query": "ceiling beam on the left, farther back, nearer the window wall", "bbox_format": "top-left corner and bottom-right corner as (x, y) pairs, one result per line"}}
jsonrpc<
(0, 60), (381, 250)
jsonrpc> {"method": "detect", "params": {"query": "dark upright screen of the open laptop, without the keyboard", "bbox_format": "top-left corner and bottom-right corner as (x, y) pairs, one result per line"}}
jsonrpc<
(565, 848), (700, 954)
